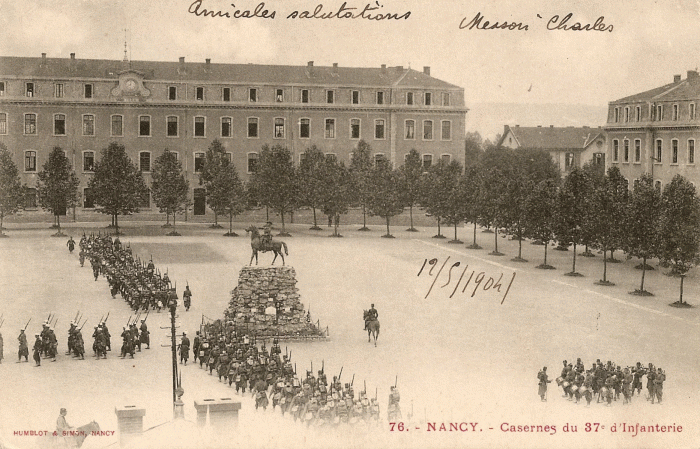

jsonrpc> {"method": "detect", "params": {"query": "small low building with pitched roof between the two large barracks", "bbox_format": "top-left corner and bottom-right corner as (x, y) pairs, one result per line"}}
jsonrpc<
(498, 125), (605, 175)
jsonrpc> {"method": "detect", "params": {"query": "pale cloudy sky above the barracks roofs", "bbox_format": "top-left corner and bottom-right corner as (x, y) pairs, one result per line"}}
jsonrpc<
(0, 0), (700, 134)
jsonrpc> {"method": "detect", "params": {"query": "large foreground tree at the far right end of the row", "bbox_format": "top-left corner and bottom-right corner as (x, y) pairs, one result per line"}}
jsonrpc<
(659, 175), (700, 305)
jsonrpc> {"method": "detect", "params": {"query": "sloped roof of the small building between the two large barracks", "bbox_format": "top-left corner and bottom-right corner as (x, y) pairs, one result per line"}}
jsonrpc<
(499, 125), (602, 150)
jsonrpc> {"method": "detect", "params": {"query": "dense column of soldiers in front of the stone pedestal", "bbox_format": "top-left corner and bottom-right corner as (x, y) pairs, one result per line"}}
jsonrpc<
(179, 320), (401, 426)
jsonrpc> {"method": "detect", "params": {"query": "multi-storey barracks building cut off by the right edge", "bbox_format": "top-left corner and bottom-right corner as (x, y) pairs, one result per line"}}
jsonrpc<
(605, 70), (700, 189)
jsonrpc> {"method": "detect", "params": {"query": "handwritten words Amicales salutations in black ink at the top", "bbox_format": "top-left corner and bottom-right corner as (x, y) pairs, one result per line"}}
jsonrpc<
(187, 0), (411, 21)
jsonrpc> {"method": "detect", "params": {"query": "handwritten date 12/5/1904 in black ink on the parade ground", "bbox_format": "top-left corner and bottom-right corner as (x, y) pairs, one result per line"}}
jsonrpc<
(418, 256), (515, 304)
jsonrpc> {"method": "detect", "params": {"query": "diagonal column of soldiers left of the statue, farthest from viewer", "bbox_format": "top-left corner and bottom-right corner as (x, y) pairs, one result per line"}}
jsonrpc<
(79, 235), (182, 312)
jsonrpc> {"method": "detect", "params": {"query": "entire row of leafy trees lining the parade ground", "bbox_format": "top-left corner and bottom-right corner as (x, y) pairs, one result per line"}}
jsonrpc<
(0, 140), (700, 304)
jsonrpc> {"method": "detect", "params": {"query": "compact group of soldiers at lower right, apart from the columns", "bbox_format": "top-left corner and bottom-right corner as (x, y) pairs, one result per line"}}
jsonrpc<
(537, 358), (666, 406)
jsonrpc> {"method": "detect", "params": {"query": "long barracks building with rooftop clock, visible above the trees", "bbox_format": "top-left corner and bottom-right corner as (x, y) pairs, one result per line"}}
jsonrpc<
(0, 53), (467, 214)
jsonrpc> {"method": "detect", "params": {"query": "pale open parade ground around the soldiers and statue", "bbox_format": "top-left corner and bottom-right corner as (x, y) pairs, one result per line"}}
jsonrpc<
(0, 225), (700, 448)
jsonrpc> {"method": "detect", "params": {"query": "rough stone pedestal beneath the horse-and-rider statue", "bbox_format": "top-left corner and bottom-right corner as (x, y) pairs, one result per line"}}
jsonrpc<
(224, 266), (325, 338)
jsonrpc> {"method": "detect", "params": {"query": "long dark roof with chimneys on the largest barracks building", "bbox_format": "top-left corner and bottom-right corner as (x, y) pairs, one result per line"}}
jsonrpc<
(0, 56), (460, 89)
